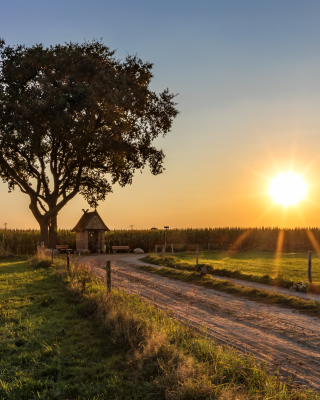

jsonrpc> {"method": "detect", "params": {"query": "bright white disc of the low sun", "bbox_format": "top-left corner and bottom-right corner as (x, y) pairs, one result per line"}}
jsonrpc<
(269, 172), (307, 206)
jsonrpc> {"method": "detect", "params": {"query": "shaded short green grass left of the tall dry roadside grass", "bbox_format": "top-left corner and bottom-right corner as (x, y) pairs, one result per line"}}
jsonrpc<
(0, 260), (138, 399)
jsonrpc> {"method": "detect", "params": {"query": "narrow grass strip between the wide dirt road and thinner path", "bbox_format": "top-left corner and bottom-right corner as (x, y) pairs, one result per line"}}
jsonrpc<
(140, 265), (320, 318)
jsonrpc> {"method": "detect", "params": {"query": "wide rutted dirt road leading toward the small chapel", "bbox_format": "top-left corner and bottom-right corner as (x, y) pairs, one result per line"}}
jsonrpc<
(80, 254), (320, 391)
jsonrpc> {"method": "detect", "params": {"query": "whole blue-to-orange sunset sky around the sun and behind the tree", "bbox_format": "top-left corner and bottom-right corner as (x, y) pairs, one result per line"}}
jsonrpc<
(0, 0), (320, 229)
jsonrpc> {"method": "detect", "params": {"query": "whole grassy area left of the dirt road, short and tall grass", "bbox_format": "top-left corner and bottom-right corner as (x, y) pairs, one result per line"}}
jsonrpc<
(0, 258), (319, 400)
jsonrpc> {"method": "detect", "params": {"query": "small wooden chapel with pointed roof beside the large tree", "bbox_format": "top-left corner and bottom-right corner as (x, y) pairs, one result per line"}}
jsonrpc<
(72, 210), (110, 253)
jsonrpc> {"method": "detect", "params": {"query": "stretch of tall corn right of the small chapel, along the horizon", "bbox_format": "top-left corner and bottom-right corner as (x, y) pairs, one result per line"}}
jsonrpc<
(94, 227), (320, 252)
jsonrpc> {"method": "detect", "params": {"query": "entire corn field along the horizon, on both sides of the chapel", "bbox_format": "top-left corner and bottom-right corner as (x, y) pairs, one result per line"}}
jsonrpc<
(0, 228), (320, 255)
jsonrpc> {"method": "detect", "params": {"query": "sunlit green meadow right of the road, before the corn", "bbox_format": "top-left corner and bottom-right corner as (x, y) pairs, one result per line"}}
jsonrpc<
(143, 251), (320, 290)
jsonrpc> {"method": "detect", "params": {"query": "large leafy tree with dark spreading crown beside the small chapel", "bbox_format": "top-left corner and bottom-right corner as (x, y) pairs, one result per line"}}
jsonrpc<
(0, 40), (178, 247)
